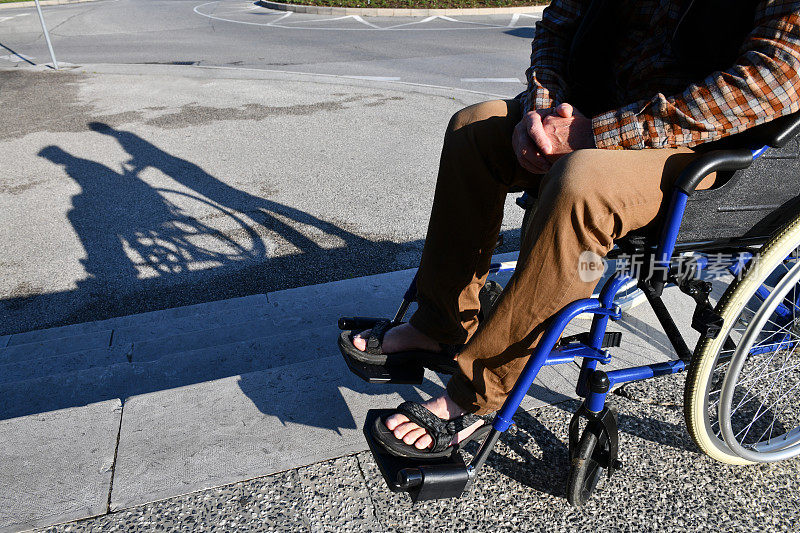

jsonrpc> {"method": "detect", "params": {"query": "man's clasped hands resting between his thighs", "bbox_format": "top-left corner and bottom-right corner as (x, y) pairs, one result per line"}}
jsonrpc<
(512, 103), (595, 174)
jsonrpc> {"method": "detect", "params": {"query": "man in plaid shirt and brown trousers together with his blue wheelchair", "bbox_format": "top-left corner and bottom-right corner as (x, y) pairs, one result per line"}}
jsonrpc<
(339, 0), (800, 505)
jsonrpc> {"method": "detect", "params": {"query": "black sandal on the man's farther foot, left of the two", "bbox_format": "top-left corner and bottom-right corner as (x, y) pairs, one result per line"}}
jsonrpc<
(339, 320), (462, 374)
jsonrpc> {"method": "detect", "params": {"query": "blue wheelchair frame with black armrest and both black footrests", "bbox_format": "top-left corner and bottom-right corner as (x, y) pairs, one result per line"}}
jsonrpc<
(346, 112), (800, 501)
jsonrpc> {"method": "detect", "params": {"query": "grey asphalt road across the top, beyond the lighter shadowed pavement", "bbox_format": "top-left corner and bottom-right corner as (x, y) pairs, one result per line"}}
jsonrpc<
(0, 0), (538, 96)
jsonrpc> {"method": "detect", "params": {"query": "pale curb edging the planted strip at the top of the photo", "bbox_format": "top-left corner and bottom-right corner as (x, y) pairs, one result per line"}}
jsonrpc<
(260, 0), (547, 17)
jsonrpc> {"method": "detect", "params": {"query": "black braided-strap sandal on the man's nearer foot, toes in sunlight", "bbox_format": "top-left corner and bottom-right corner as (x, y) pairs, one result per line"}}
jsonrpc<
(372, 402), (494, 459)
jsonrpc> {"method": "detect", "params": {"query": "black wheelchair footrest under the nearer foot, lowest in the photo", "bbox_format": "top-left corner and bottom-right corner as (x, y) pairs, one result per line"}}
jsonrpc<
(364, 409), (469, 502)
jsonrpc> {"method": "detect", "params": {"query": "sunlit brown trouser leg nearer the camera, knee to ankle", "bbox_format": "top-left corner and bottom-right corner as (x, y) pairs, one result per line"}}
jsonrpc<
(447, 149), (712, 414)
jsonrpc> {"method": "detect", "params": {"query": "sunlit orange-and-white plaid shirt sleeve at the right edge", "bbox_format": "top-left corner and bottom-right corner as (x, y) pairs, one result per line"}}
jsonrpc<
(592, 0), (800, 149)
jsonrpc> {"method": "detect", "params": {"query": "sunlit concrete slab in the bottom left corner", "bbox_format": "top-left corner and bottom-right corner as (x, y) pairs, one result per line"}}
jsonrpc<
(0, 400), (122, 532)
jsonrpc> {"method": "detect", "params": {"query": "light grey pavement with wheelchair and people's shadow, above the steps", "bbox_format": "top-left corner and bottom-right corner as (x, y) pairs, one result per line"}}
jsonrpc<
(0, 65), (522, 335)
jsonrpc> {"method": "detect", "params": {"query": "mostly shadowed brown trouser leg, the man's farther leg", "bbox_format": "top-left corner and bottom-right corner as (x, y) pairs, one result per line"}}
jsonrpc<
(410, 100), (540, 344)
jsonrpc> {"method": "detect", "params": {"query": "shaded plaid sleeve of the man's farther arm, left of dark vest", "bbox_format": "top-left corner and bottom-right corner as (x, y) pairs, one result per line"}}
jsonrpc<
(522, 0), (590, 112)
